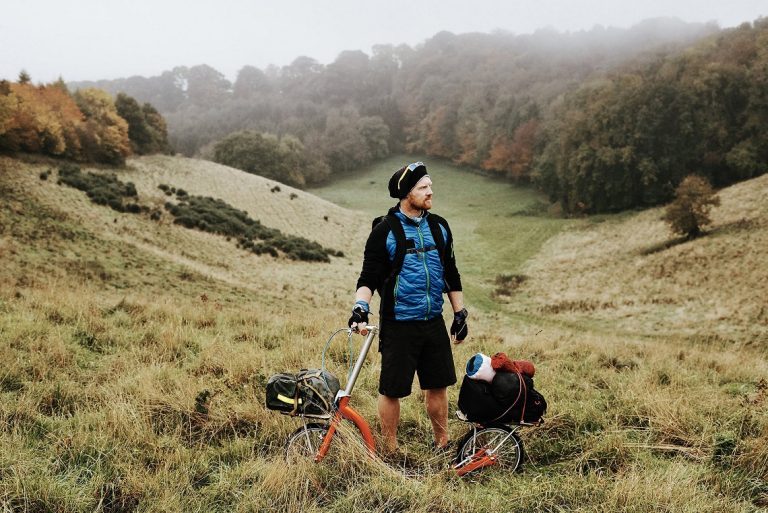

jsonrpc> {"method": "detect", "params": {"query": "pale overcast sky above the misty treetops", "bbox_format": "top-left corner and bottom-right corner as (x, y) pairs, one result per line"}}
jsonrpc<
(0, 0), (768, 83)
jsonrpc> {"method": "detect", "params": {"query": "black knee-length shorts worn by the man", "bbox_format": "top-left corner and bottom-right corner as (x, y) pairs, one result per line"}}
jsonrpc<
(379, 316), (456, 397)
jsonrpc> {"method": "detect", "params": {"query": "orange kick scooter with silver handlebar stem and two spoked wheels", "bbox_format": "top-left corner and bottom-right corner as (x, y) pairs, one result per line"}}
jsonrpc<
(285, 326), (534, 476)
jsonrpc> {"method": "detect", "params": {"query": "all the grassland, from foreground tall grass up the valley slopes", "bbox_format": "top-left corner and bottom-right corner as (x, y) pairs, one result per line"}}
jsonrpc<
(0, 157), (768, 512)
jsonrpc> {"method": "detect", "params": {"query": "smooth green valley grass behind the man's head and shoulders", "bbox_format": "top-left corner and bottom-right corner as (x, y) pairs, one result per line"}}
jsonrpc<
(310, 156), (574, 311)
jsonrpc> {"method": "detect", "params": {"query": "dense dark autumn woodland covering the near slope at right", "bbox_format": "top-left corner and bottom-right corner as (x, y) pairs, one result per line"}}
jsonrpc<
(531, 19), (768, 212)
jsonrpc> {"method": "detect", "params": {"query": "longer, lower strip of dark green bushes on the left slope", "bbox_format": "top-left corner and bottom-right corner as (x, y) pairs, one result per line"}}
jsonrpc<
(165, 194), (343, 262)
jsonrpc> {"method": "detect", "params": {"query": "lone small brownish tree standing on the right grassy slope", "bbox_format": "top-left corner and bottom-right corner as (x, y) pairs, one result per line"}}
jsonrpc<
(664, 175), (720, 239)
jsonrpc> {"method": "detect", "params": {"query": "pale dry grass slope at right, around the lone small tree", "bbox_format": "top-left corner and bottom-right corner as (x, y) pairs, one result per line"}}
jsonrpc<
(522, 171), (768, 349)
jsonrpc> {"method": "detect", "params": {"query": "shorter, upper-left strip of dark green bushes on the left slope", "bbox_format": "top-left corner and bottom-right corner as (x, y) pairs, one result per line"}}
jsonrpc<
(58, 164), (142, 214)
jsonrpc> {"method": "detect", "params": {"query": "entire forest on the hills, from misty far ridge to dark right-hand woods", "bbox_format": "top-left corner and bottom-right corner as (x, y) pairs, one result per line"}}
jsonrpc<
(70, 19), (768, 213)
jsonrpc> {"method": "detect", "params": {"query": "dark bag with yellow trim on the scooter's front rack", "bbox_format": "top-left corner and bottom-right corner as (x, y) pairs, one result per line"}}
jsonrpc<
(266, 369), (341, 417)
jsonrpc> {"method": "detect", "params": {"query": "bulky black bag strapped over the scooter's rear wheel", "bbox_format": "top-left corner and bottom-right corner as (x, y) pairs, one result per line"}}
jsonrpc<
(459, 372), (547, 423)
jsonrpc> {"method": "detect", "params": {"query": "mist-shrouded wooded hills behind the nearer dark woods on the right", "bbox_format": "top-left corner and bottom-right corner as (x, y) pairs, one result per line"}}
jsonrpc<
(69, 19), (717, 168)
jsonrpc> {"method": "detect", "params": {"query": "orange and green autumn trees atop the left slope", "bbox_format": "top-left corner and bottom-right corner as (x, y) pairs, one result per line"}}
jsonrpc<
(0, 71), (170, 165)
